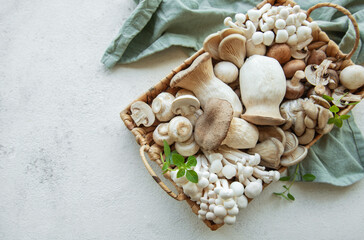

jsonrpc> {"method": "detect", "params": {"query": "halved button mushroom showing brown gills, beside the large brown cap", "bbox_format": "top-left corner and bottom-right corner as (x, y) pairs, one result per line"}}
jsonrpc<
(171, 95), (200, 116)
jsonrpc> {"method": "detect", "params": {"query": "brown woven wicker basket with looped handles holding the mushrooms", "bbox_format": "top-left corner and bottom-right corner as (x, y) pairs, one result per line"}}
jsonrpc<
(120, 0), (364, 230)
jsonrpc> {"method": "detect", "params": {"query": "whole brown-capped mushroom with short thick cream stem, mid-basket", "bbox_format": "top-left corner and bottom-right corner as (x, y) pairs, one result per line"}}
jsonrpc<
(194, 98), (259, 151)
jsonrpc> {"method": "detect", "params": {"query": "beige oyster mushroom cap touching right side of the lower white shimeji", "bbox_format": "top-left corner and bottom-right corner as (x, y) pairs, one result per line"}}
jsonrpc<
(249, 137), (284, 169)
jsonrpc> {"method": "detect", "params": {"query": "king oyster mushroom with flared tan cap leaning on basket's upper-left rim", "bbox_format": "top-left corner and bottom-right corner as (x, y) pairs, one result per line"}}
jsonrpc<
(170, 53), (243, 116)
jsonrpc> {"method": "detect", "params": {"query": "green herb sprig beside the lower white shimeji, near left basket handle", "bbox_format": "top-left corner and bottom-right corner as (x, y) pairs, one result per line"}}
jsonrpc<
(161, 140), (198, 183)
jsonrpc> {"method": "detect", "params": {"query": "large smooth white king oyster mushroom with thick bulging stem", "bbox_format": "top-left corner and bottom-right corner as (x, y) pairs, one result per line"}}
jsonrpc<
(239, 55), (286, 125)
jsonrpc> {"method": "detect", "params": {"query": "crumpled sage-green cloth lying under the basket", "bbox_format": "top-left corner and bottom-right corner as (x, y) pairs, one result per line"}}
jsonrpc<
(102, 0), (364, 186)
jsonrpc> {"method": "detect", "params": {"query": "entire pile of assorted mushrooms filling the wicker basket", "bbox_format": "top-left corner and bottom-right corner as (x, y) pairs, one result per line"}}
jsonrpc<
(130, 3), (364, 224)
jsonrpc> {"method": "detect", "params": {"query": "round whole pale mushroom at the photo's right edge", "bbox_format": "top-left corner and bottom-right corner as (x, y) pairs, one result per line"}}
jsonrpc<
(340, 65), (364, 90)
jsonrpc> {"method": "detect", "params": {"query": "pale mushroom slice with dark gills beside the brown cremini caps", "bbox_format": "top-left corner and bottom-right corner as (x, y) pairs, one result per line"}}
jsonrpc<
(305, 59), (332, 95)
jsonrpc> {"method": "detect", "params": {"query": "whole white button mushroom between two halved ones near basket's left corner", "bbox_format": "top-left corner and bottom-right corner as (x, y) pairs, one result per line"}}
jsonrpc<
(152, 92), (175, 122)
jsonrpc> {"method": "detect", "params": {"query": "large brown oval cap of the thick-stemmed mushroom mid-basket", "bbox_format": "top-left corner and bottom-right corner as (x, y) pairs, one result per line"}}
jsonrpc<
(194, 98), (233, 151)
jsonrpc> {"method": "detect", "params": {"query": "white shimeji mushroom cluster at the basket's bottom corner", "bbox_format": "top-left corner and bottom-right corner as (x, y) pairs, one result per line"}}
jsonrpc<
(171, 146), (280, 224)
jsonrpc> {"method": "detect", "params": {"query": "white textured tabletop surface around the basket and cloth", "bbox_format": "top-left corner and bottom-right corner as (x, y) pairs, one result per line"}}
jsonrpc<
(0, 0), (364, 240)
